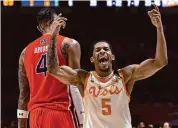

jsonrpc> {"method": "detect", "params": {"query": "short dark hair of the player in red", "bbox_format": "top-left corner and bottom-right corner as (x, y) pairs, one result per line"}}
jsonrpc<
(36, 8), (57, 24)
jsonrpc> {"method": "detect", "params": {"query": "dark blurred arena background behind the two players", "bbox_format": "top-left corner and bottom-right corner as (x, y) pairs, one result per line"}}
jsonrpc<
(1, 0), (178, 127)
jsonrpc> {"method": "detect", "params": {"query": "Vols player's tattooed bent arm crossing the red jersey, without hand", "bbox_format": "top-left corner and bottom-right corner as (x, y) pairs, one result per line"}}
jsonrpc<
(47, 18), (88, 85)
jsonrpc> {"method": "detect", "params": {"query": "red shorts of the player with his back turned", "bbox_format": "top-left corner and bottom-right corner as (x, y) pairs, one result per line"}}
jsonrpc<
(30, 107), (74, 128)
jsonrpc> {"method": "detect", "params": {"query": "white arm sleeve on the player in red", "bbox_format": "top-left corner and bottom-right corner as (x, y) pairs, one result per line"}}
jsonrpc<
(70, 85), (84, 124)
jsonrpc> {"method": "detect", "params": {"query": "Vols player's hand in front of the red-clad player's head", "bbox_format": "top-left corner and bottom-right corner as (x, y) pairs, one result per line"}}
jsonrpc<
(51, 13), (67, 36)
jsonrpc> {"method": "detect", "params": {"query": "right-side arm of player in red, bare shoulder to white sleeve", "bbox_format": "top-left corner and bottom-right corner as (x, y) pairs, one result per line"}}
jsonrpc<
(61, 38), (85, 128)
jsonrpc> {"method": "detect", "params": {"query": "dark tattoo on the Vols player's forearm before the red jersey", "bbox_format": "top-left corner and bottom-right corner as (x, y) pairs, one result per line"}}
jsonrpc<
(47, 37), (58, 72)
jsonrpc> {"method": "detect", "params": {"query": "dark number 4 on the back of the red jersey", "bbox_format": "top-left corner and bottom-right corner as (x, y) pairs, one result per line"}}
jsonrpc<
(36, 54), (47, 76)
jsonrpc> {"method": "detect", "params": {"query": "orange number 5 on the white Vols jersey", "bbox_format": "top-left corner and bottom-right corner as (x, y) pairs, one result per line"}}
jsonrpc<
(101, 98), (111, 115)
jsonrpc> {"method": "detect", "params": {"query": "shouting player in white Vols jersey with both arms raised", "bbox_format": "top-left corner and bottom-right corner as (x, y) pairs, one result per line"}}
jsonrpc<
(47, 6), (168, 128)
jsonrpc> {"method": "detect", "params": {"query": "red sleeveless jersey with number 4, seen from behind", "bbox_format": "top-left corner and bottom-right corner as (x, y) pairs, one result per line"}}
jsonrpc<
(24, 34), (70, 111)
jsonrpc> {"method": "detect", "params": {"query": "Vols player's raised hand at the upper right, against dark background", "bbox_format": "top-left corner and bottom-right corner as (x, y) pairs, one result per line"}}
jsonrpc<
(148, 4), (163, 29)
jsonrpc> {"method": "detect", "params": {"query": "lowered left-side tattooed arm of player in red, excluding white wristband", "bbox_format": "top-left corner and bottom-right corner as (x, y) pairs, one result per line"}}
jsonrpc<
(18, 50), (30, 128)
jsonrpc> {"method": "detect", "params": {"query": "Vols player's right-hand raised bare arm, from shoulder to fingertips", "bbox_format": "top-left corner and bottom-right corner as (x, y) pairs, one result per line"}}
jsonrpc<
(122, 5), (168, 93)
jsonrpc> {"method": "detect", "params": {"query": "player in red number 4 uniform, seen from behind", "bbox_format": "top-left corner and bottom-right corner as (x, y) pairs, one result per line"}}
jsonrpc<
(17, 8), (81, 128)
